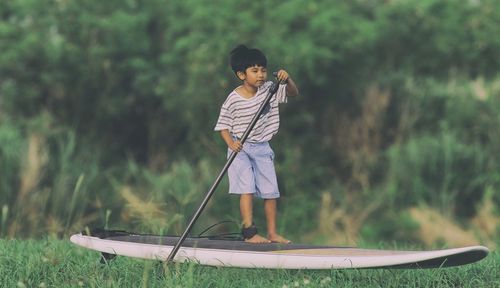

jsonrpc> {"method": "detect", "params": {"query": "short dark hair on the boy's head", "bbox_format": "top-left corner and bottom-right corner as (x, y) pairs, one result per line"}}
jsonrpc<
(229, 45), (267, 73)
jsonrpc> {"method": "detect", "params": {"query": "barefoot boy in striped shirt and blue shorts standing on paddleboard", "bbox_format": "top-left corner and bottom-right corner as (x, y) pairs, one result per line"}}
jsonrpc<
(214, 45), (299, 243)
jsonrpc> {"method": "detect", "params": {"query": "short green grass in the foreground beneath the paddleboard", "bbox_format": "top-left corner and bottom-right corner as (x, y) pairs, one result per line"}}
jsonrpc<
(0, 240), (500, 288)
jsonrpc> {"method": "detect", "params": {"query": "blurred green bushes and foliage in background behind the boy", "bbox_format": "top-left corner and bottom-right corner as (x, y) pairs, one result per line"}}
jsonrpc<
(0, 0), (500, 244)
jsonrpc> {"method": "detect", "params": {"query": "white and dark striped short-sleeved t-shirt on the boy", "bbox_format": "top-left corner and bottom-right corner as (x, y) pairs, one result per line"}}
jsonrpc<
(214, 81), (287, 142)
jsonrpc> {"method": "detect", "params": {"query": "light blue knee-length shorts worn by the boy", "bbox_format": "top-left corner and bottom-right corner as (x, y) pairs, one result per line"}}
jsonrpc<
(227, 142), (280, 199)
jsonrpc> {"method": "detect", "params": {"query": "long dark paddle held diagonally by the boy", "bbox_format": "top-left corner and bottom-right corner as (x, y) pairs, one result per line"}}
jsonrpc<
(167, 72), (279, 263)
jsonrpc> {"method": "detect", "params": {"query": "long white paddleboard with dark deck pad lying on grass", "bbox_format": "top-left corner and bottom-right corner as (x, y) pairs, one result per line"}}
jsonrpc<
(70, 231), (489, 269)
